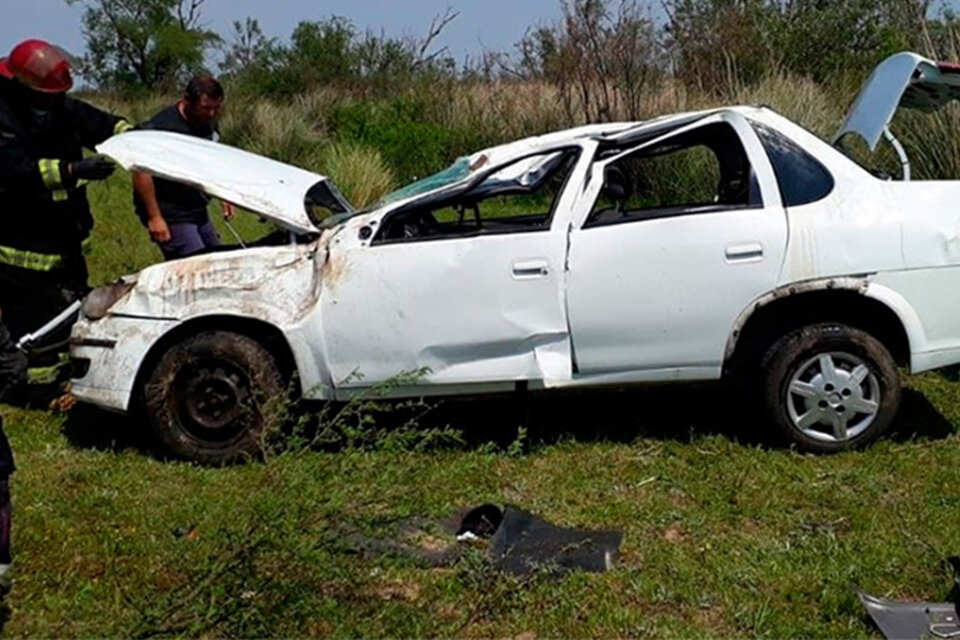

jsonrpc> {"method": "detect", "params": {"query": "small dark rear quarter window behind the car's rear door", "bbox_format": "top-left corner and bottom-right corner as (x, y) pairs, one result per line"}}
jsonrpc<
(750, 121), (834, 207)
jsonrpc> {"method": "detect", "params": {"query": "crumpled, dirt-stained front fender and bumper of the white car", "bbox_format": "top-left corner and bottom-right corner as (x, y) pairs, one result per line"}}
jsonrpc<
(71, 240), (335, 410)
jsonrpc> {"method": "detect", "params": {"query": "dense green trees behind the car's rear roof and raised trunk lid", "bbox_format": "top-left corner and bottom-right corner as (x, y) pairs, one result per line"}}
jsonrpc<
(663, 0), (950, 93)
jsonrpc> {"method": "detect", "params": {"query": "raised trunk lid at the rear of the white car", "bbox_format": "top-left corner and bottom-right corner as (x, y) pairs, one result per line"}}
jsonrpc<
(833, 52), (960, 151)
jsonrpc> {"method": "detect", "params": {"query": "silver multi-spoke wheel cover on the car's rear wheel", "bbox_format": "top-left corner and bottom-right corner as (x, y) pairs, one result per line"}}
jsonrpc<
(785, 351), (881, 442)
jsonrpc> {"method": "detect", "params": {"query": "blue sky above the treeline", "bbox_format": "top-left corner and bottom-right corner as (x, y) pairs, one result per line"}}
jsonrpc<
(0, 0), (561, 65)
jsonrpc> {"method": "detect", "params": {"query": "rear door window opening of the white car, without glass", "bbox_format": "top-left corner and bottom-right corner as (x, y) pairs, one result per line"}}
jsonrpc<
(584, 122), (762, 227)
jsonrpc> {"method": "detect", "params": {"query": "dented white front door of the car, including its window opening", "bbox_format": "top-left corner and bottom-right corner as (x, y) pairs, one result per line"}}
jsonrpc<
(321, 149), (589, 389)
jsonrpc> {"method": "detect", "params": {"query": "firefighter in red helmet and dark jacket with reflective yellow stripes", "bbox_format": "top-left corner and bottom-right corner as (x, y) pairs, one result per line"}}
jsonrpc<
(0, 40), (132, 372)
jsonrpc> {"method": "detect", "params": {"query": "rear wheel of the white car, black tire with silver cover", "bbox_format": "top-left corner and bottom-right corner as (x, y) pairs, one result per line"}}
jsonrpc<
(759, 323), (900, 453)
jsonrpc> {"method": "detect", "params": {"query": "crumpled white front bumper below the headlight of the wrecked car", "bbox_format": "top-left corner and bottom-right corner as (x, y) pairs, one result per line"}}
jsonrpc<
(70, 315), (178, 411)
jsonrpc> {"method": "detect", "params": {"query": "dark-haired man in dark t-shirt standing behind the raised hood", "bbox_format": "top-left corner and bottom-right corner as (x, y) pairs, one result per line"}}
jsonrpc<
(133, 75), (234, 260)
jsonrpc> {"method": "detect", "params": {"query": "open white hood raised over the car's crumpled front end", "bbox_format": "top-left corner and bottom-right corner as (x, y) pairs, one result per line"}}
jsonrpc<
(97, 131), (352, 233)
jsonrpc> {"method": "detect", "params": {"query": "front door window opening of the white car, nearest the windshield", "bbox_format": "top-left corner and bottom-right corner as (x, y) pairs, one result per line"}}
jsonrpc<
(375, 150), (578, 243)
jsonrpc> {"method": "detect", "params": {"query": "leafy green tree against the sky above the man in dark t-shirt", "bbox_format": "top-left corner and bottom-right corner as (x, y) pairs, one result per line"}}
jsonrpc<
(64, 0), (219, 91)
